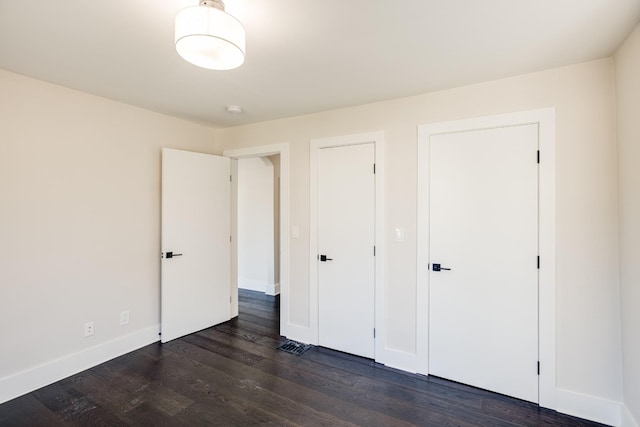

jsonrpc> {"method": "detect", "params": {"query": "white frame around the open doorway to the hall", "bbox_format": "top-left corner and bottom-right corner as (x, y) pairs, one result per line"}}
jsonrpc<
(222, 144), (292, 337)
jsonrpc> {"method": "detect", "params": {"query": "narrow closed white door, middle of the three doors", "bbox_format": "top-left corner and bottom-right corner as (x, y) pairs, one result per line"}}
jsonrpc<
(317, 143), (375, 358)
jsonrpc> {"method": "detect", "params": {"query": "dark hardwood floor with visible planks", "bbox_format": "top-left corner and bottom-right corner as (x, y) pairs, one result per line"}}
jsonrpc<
(0, 291), (598, 426)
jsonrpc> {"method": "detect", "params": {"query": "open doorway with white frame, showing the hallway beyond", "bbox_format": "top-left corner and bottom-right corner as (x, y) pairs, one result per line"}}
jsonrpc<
(223, 144), (295, 337)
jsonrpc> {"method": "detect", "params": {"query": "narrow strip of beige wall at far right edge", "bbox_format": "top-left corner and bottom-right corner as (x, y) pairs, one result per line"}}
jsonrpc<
(614, 22), (640, 423)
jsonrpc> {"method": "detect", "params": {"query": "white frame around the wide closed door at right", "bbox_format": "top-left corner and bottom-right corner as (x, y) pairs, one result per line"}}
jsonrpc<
(416, 108), (556, 409)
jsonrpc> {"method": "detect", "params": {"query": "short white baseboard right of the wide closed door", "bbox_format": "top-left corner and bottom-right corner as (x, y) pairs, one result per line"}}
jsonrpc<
(556, 389), (622, 426)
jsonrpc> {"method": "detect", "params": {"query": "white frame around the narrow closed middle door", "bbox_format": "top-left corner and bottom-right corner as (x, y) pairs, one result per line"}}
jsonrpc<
(309, 132), (386, 363)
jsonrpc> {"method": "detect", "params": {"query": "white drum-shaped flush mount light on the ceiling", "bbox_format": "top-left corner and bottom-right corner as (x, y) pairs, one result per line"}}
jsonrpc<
(176, 0), (245, 70)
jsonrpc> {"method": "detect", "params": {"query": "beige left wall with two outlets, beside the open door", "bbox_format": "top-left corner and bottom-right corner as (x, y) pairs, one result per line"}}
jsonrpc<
(0, 70), (219, 382)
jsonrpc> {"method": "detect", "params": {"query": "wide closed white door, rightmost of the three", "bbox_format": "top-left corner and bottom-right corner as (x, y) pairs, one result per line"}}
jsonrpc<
(429, 124), (539, 402)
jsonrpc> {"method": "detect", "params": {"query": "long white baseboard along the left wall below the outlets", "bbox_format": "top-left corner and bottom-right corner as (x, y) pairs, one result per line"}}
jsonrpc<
(0, 325), (160, 403)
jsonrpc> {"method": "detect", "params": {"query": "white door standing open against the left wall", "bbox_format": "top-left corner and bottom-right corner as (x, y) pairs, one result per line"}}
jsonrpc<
(161, 148), (231, 342)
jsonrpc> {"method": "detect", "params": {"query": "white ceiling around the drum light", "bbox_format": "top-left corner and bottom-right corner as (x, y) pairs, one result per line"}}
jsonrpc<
(0, 0), (640, 127)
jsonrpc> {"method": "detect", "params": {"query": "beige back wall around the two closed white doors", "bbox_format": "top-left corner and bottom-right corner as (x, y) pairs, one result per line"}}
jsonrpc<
(219, 59), (622, 402)
